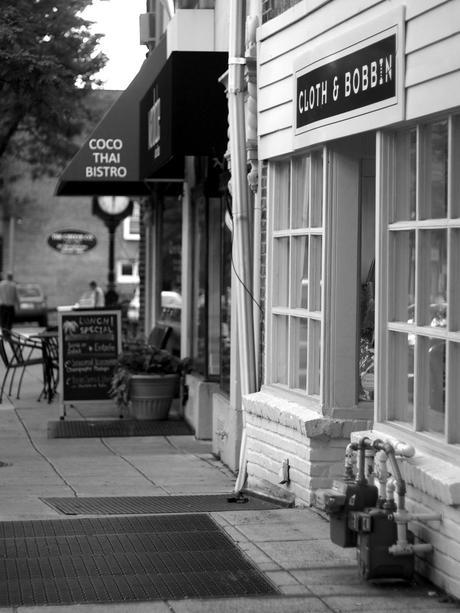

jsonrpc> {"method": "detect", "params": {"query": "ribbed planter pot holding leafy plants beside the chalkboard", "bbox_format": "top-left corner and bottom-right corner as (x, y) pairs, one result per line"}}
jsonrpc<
(129, 374), (180, 420)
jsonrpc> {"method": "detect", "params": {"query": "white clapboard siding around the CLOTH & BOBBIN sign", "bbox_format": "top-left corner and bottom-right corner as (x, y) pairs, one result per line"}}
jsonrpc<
(258, 0), (460, 159)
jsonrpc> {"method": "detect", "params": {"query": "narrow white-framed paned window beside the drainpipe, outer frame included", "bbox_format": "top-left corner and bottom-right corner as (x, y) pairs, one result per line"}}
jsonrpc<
(264, 148), (326, 410)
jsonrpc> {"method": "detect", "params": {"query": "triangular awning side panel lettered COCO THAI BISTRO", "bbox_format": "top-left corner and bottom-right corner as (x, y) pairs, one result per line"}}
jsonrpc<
(55, 39), (166, 196)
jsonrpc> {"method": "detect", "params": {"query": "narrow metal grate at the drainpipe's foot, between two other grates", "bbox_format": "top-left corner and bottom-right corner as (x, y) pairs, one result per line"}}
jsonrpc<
(40, 494), (283, 515)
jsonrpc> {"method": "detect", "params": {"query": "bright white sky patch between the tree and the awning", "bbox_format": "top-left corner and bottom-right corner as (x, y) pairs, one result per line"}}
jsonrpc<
(83, 0), (147, 90)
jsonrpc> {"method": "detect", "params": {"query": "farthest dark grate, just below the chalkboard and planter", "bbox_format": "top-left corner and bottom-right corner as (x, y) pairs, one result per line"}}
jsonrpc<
(48, 419), (194, 438)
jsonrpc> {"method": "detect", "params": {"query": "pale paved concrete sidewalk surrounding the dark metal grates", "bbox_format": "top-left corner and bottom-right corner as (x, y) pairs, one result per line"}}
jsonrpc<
(0, 368), (458, 613)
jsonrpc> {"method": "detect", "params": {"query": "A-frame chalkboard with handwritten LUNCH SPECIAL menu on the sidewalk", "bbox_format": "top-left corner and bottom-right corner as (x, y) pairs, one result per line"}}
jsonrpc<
(59, 309), (121, 403)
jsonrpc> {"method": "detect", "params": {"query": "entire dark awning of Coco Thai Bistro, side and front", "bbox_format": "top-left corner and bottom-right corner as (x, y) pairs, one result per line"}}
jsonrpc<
(56, 41), (227, 196)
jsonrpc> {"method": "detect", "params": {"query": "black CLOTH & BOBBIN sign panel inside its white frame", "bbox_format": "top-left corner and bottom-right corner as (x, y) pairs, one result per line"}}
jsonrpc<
(296, 34), (397, 128)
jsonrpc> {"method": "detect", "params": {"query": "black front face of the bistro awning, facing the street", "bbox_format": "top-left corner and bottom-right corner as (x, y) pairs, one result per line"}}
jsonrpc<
(140, 51), (228, 179)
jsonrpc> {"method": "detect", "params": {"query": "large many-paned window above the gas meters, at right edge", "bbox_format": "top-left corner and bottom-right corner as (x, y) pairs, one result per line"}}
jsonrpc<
(384, 116), (460, 443)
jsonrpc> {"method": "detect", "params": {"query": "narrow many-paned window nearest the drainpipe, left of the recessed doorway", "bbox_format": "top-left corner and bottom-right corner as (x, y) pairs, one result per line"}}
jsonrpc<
(267, 151), (324, 396)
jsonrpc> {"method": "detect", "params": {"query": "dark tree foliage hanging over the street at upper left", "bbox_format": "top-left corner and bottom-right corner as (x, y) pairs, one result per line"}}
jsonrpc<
(0, 0), (107, 174)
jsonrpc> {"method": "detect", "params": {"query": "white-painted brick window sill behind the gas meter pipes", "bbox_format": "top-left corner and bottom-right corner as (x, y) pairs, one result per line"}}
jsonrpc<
(351, 423), (460, 506)
